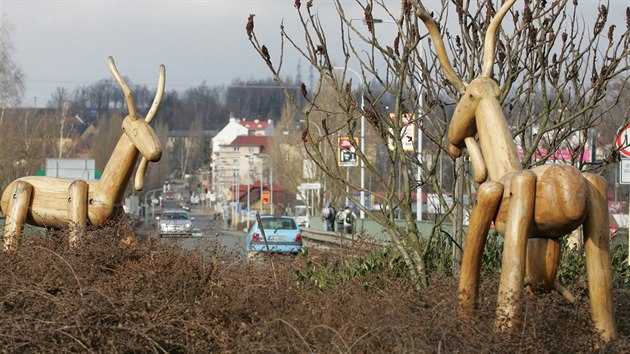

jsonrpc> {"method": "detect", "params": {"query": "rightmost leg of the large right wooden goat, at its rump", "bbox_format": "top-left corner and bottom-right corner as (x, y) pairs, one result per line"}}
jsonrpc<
(584, 174), (617, 341)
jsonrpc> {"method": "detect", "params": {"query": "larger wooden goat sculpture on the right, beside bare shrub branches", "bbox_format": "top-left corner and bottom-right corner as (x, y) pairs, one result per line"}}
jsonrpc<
(418, 0), (616, 340)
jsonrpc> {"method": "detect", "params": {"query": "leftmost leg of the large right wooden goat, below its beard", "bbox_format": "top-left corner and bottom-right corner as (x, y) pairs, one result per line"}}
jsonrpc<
(458, 181), (503, 315)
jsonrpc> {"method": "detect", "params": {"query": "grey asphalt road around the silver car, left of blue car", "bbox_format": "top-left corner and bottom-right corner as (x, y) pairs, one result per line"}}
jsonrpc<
(136, 200), (245, 256)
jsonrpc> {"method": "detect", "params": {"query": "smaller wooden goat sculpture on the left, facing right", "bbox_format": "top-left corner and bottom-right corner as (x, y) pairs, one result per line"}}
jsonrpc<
(0, 57), (165, 250)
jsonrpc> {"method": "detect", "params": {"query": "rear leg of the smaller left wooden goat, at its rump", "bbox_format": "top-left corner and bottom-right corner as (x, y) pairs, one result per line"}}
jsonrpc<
(4, 181), (33, 251)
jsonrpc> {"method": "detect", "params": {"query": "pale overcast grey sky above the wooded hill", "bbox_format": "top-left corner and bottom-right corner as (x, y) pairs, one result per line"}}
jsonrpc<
(0, 0), (630, 107)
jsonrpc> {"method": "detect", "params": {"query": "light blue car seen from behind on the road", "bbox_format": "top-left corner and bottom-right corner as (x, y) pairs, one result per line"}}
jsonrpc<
(245, 215), (302, 253)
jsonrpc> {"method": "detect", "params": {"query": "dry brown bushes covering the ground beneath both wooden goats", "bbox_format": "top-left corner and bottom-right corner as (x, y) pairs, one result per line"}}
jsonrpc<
(0, 225), (630, 353)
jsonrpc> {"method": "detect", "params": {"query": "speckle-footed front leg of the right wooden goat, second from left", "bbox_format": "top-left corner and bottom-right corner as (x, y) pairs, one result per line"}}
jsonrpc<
(495, 171), (536, 331)
